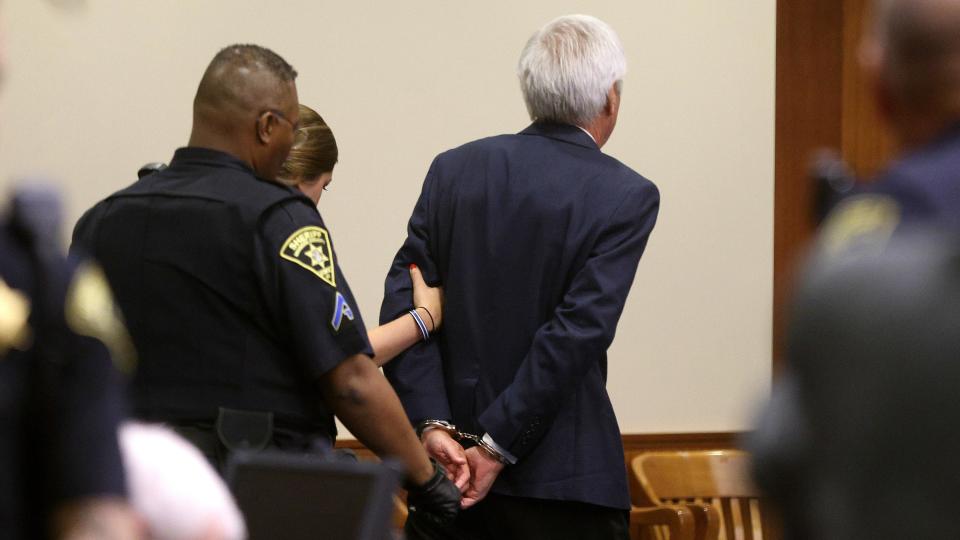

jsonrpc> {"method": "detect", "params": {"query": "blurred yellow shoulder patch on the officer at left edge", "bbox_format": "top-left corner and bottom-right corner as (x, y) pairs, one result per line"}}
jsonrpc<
(64, 262), (137, 374)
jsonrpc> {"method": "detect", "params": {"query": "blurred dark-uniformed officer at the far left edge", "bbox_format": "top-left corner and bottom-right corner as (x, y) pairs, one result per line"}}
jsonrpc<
(0, 190), (138, 539)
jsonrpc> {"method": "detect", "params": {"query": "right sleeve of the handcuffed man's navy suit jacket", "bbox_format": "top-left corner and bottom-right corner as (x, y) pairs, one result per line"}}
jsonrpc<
(478, 182), (660, 459)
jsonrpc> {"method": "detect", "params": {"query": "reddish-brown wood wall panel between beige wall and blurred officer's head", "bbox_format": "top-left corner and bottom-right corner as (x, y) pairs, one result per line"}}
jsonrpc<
(773, 0), (896, 375)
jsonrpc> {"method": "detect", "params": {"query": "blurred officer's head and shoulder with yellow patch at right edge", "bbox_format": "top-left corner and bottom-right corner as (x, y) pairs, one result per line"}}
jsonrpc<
(823, 0), (960, 250)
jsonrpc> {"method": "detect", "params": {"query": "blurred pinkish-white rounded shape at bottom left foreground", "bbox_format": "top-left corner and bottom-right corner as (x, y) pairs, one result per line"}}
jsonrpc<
(119, 422), (247, 540)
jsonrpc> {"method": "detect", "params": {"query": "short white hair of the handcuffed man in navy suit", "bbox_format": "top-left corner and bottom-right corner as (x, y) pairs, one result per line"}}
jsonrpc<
(517, 15), (627, 126)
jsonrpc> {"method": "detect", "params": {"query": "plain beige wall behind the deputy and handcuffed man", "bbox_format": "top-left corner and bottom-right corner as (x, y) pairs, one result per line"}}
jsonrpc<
(0, 0), (775, 432)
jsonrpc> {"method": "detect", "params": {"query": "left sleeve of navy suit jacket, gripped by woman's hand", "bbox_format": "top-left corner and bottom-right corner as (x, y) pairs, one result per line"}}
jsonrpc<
(380, 161), (452, 425)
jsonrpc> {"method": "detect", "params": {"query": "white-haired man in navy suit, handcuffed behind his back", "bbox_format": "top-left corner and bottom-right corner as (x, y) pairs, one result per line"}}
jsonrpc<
(381, 15), (660, 539)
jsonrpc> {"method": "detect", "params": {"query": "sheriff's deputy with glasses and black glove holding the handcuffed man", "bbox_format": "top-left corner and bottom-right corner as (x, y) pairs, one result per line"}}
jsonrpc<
(74, 45), (459, 518)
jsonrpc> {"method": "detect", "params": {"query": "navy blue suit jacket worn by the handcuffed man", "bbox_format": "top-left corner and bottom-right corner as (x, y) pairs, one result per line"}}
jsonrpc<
(381, 124), (660, 508)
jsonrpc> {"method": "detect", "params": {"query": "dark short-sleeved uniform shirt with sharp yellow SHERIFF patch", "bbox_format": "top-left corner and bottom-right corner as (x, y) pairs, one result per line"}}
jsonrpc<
(74, 148), (372, 439)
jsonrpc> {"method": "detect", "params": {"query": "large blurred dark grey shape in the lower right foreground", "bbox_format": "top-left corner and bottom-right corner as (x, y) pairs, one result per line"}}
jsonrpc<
(751, 229), (960, 540)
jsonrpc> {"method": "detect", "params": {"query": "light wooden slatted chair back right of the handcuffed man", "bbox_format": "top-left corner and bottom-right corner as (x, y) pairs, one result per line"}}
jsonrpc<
(631, 450), (772, 540)
